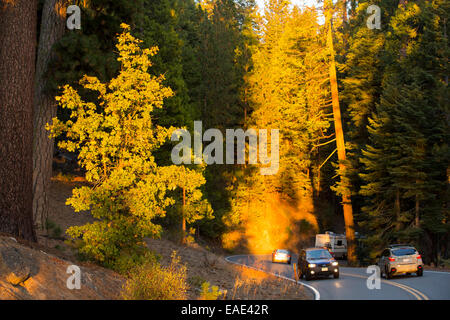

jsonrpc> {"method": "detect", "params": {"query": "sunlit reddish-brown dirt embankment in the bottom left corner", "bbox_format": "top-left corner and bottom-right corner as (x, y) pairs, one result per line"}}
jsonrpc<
(0, 236), (125, 300)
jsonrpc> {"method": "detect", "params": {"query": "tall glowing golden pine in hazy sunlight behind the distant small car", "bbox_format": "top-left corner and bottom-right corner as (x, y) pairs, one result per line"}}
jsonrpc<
(226, 0), (329, 250)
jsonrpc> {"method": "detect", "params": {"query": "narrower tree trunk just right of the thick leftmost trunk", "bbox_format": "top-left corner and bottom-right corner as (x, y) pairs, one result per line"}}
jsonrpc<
(33, 0), (69, 228)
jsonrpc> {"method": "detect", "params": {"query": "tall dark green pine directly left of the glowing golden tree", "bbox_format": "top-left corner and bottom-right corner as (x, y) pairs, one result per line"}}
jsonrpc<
(191, 0), (256, 237)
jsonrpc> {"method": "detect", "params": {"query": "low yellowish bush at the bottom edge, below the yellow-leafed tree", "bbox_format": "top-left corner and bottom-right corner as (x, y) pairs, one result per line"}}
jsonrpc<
(122, 252), (188, 300)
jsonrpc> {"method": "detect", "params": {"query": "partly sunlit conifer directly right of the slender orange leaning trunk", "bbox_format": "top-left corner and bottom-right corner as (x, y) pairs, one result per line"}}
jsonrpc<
(339, 0), (398, 260)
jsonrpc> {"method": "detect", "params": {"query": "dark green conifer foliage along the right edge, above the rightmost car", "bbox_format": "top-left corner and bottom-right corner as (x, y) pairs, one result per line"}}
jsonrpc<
(360, 1), (449, 259)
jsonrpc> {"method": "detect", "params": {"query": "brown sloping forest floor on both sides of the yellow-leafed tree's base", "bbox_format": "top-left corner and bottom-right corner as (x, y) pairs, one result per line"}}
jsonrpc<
(0, 175), (313, 300)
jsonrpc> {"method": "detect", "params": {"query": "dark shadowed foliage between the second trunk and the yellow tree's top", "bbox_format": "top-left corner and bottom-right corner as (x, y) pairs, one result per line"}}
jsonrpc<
(48, 0), (144, 89)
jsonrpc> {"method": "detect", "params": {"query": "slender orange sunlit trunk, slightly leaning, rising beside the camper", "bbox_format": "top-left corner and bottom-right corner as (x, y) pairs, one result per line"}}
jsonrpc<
(326, 0), (356, 264)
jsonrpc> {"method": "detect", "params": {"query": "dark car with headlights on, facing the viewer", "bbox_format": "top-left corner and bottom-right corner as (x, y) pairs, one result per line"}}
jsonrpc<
(297, 248), (339, 280)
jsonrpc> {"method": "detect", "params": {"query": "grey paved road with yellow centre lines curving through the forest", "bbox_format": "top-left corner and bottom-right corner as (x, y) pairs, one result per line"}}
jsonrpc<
(227, 255), (450, 300)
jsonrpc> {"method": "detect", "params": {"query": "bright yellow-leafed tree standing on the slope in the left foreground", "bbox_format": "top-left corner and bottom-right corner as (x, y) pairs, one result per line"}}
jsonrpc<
(49, 24), (210, 266)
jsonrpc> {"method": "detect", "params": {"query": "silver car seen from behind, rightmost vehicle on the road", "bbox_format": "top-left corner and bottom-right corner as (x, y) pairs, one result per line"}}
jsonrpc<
(378, 245), (423, 279)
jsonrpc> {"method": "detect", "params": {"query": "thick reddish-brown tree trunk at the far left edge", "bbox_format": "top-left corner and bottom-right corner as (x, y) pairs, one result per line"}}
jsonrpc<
(0, 0), (37, 241)
